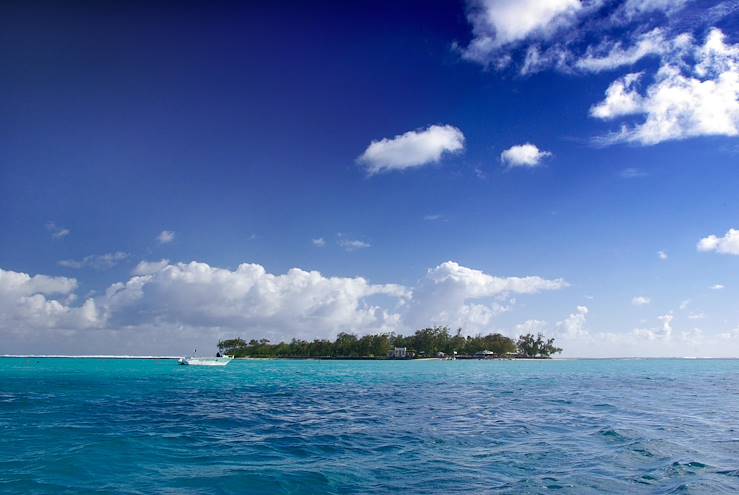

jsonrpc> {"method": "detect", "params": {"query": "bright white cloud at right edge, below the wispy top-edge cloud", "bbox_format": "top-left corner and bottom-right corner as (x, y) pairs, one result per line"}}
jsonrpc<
(590, 29), (739, 145)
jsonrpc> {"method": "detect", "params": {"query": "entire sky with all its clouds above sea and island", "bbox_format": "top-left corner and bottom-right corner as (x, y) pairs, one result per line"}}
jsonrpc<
(0, 0), (739, 357)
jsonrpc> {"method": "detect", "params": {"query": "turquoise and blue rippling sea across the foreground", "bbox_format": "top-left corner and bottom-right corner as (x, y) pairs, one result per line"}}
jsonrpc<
(0, 359), (739, 494)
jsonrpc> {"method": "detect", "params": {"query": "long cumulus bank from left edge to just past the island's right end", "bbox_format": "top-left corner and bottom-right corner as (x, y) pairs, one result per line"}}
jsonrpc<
(0, 260), (567, 352)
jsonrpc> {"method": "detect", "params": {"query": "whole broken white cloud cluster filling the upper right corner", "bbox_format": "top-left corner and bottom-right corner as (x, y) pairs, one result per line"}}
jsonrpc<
(460, 0), (739, 145)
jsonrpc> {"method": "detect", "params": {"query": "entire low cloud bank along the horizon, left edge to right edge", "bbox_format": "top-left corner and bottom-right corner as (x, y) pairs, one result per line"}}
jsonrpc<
(0, 247), (739, 357)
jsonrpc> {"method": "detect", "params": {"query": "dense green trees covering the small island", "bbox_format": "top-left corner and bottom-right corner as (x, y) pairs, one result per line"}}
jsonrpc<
(218, 327), (562, 359)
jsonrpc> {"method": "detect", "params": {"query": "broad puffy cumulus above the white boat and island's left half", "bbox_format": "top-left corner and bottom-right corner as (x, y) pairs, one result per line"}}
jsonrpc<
(100, 262), (409, 338)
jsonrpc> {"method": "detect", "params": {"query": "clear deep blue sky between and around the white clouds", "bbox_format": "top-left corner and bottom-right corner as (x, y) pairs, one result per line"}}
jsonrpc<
(0, 2), (739, 354)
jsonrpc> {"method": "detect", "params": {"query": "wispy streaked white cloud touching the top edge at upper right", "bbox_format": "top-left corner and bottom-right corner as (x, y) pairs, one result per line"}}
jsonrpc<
(454, 0), (736, 75)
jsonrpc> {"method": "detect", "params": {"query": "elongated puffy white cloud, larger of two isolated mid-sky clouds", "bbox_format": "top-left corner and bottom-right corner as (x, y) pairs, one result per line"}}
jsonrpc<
(357, 125), (464, 175)
